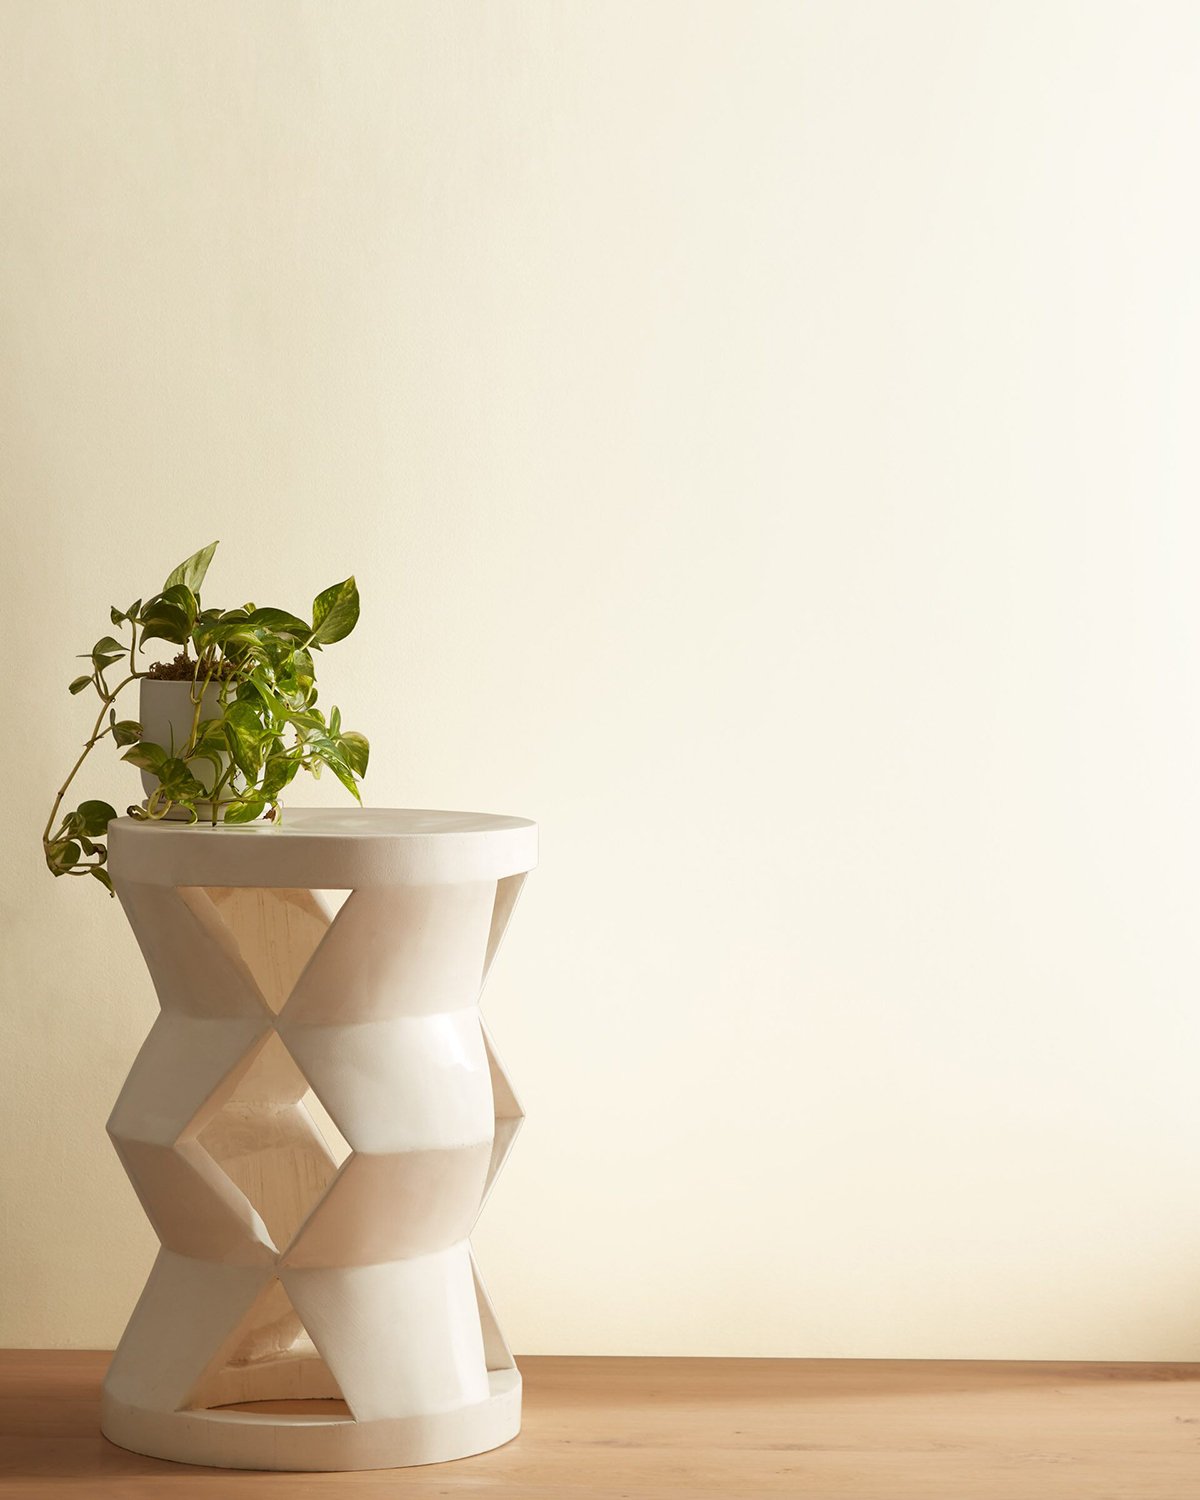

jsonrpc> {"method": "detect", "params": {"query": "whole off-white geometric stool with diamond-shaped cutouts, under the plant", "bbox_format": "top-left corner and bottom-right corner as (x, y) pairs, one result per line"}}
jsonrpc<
(102, 809), (537, 1470)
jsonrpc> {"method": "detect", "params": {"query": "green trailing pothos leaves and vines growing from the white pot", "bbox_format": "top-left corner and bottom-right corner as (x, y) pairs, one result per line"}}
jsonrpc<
(42, 542), (369, 894)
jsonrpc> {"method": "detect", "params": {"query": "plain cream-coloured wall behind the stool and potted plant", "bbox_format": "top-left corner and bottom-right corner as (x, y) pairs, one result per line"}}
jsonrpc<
(0, 0), (1200, 1359)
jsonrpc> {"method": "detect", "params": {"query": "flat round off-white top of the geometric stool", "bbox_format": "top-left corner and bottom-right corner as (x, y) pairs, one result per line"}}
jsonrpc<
(108, 807), (537, 891)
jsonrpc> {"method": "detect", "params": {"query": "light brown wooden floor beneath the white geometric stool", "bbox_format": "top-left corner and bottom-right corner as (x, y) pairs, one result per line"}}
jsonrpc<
(0, 1350), (1200, 1500)
